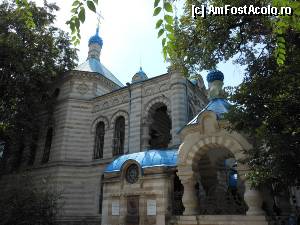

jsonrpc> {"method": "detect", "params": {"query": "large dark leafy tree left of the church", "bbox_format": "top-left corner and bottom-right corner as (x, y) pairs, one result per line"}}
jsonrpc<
(0, 2), (77, 168)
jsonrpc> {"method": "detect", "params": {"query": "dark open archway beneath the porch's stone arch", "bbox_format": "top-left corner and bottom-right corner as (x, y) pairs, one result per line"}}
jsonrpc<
(194, 147), (247, 215)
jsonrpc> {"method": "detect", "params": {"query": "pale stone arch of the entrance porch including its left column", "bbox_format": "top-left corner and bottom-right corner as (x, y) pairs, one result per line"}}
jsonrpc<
(177, 133), (251, 215)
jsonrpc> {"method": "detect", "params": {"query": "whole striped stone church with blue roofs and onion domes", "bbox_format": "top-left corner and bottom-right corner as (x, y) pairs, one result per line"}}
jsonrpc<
(1, 25), (296, 225)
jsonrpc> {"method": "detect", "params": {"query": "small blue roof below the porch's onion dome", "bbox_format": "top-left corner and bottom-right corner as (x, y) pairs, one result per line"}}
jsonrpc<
(187, 98), (230, 125)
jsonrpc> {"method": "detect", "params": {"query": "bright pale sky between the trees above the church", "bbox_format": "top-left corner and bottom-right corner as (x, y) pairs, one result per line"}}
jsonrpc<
(35, 0), (244, 86)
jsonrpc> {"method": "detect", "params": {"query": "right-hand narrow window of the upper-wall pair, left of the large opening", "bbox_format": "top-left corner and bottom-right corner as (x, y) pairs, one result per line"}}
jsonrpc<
(113, 116), (125, 156)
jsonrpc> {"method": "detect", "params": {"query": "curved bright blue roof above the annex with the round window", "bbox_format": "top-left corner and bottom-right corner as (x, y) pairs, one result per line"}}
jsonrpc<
(104, 149), (178, 173)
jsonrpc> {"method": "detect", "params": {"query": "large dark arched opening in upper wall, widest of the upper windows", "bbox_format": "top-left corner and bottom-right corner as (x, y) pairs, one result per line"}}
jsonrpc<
(149, 106), (172, 149)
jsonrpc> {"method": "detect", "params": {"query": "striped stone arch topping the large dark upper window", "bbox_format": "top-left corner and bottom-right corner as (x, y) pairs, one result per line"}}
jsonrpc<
(144, 96), (171, 119)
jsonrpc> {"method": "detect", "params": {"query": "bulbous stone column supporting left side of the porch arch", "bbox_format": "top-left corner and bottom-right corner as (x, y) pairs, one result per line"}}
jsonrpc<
(181, 178), (199, 215)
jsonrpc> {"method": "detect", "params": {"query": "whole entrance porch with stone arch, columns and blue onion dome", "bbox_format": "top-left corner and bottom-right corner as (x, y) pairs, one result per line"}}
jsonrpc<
(177, 71), (267, 225)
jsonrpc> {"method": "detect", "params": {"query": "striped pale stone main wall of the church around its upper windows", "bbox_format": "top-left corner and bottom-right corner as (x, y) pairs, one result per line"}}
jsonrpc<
(1, 71), (206, 224)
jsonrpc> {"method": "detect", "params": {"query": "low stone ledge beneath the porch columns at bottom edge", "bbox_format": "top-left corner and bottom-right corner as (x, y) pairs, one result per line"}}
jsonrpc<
(173, 215), (268, 225)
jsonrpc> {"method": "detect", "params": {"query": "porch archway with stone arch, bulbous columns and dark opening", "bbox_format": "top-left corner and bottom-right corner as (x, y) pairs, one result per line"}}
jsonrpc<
(177, 129), (263, 215)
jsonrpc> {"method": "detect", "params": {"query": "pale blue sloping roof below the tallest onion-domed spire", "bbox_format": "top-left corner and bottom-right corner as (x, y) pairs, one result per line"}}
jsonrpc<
(75, 58), (124, 87)
